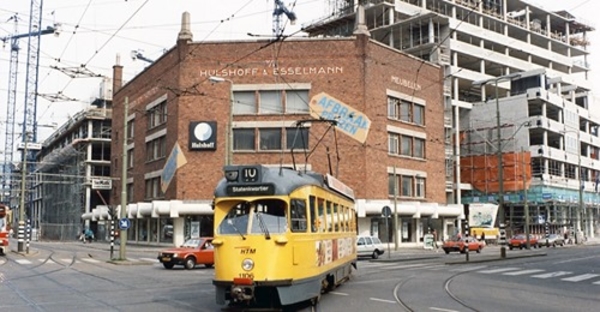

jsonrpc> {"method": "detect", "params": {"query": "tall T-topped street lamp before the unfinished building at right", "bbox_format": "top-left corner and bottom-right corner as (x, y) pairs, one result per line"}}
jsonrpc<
(473, 73), (521, 258)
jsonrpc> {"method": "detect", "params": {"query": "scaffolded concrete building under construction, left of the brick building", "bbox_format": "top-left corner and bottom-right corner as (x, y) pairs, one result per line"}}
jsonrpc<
(28, 79), (112, 240)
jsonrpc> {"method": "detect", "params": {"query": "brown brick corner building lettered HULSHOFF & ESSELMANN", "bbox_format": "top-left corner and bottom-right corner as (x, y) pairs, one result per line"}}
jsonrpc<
(92, 11), (462, 244)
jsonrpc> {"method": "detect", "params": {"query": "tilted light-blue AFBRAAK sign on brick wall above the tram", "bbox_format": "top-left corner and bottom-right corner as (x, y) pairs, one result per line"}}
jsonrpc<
(310, 92), (371, 143)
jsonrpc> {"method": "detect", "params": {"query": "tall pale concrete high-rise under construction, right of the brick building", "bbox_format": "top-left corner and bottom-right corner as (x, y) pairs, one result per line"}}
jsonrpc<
(304, 0), (598, 239)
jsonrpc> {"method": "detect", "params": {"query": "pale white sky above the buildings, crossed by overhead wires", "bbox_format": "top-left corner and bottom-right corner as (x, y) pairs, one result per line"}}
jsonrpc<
(0, 0), (600, 146)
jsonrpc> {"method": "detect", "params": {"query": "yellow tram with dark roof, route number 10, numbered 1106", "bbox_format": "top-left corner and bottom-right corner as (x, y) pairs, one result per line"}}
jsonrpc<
(213, 165), (357, 307)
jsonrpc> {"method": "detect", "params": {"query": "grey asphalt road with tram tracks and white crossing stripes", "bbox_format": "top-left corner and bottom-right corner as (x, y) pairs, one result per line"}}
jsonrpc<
(0, 242), (600, 312)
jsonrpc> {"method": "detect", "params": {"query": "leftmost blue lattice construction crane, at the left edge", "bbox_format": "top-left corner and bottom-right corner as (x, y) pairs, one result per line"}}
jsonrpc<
(1, 14), (58, 204)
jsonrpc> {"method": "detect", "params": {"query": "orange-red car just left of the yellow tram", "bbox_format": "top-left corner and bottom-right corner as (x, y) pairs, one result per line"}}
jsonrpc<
(158, 237), (215, 270)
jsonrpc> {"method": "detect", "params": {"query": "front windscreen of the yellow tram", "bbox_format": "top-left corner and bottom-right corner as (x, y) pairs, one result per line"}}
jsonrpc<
(217, 199), (288, 238)
